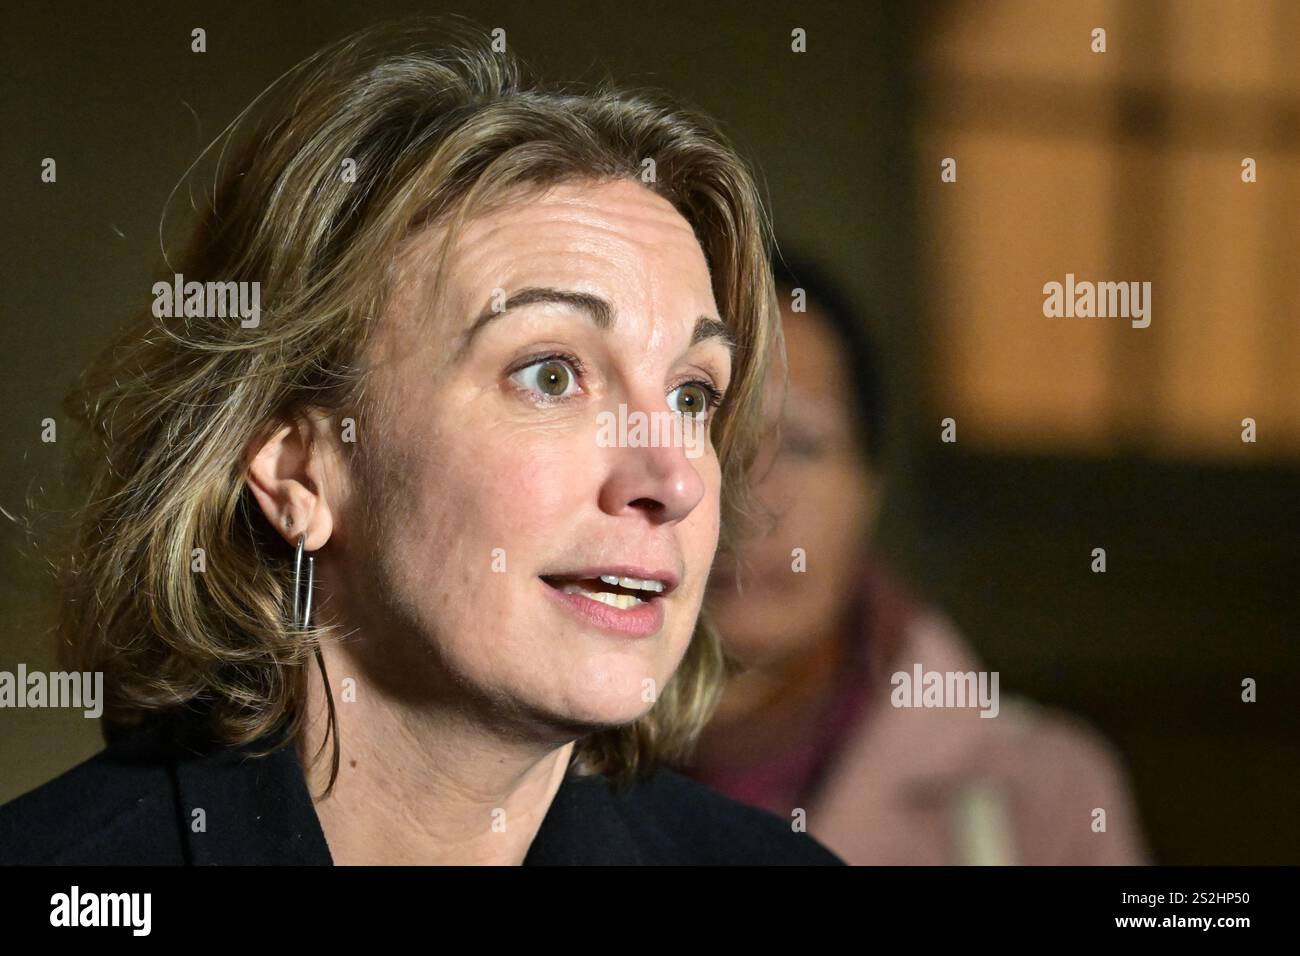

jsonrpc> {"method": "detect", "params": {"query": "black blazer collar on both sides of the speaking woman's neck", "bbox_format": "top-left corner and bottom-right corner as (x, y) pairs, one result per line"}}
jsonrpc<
(173, 721), (642, 866)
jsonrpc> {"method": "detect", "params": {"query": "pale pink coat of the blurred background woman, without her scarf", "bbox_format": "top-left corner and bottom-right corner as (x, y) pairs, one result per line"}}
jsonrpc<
(807, 611), (1148, 865)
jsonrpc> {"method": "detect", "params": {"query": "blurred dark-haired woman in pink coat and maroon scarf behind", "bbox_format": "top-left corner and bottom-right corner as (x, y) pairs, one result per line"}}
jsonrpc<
(689, 254), (1145, 864)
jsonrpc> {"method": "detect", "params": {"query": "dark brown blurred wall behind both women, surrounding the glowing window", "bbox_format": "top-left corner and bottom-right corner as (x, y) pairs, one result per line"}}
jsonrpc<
(0, 0), (1300, 862)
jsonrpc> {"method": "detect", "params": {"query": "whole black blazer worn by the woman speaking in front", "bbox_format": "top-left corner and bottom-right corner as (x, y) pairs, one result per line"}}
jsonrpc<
(0, 718), (844, 866)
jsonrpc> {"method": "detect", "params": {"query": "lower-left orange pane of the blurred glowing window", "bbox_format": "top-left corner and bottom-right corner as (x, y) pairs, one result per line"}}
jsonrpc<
(927, 133), (1113, 447)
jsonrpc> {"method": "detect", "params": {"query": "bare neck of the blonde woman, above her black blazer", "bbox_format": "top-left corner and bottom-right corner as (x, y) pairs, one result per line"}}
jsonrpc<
(298, 648), (573, 865)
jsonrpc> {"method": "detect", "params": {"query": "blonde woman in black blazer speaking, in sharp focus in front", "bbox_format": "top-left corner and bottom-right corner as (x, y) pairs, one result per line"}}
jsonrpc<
(0, 14), (839, 864)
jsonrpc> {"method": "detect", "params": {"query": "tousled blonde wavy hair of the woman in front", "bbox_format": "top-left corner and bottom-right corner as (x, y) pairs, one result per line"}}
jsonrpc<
(59, 17), (780, 792)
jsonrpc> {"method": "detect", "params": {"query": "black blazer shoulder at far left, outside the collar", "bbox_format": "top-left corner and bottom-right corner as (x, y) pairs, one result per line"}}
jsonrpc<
(0, 723), (183, 865)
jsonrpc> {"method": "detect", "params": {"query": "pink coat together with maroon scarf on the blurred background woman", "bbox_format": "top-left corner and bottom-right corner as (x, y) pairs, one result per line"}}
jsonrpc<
(685, 558), (1148, 865)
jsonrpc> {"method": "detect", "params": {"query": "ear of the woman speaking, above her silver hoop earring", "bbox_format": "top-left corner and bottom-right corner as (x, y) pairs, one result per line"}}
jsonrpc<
(247, 420), (334, 551)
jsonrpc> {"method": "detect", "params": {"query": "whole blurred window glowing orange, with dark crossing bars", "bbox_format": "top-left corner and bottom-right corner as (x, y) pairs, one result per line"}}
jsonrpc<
(919, 0), (1300, 462)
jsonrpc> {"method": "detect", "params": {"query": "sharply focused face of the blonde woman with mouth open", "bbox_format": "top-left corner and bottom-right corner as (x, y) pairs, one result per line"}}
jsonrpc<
(330, 181), (731, 734)
